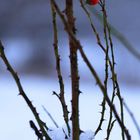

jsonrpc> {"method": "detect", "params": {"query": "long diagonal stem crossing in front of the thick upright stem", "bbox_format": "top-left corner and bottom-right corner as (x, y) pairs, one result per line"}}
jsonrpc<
(51, 0), (131, 140)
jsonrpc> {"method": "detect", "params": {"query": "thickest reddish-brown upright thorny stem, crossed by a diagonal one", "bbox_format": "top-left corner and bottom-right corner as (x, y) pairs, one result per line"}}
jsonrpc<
(65, 0), (80, 140)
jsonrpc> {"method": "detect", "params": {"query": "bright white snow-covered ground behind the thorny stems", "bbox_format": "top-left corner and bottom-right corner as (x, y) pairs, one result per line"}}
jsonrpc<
(0, 74), (140, 140)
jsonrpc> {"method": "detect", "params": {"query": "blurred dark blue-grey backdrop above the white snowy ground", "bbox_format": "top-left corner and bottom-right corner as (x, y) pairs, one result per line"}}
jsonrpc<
(0, 0), (140, 85)
